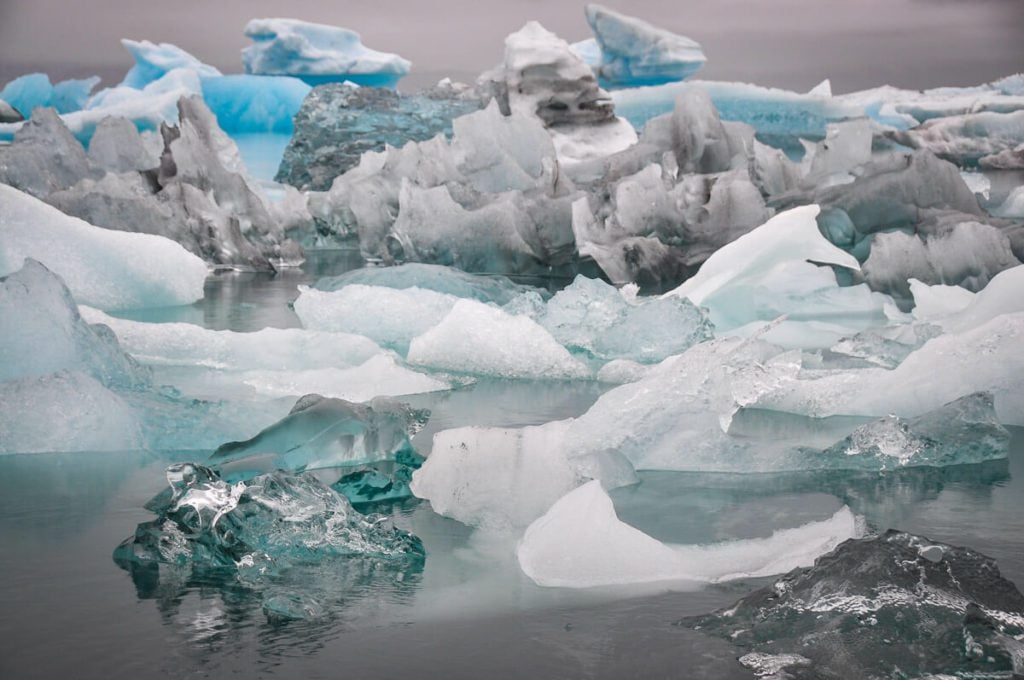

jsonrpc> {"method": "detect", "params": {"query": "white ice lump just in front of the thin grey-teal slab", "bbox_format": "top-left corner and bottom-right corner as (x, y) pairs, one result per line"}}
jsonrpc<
(295, 284), (459, 353)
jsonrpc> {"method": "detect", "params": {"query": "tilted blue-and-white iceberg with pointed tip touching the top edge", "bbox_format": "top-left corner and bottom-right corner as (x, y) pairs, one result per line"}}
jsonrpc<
(572, 4), (707, 87)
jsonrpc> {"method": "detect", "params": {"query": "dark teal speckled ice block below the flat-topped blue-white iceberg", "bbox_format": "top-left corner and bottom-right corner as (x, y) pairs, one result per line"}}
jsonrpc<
(275, 83), (482, 192)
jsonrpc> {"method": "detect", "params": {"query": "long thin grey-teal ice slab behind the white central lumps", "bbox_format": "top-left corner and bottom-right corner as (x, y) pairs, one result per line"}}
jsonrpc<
(313, 262), (542, 305)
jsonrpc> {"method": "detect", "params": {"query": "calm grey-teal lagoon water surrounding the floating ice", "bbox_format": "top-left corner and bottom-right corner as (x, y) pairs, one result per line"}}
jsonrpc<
(6, 256), (1024, 678)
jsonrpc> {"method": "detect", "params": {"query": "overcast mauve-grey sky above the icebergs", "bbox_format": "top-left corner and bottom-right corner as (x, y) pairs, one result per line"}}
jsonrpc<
(0, 0), (1024, 91)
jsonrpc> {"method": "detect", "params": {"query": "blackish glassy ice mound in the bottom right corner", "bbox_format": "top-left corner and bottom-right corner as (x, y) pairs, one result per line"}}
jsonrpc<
(676, 530), (1024, 678)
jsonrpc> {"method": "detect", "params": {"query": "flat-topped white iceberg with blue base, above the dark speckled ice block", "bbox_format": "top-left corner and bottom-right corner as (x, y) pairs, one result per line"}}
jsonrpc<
(242, 18), (412, 87)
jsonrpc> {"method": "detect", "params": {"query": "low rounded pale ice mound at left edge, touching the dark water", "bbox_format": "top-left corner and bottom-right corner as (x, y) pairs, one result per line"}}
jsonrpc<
(0, 368), (144, 454)
